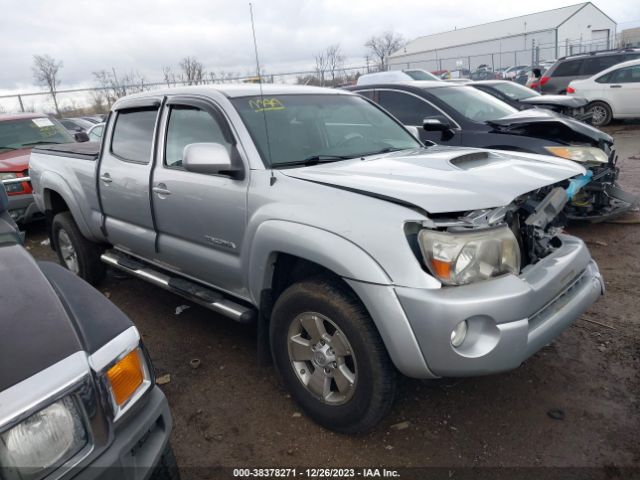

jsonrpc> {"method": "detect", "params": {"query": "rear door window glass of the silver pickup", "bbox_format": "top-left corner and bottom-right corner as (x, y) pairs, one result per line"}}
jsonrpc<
(111, 108), (158, 163)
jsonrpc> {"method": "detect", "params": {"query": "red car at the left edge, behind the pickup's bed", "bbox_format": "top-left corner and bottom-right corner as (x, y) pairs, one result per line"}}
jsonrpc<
(0, 113), (80, 223)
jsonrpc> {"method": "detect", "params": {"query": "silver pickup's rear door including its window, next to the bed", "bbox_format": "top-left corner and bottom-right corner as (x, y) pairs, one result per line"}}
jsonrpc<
(99, 98), (161, 258)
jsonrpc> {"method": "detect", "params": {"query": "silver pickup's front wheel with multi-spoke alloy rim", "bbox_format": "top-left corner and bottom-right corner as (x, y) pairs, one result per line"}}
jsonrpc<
(270, 275), (397, 433)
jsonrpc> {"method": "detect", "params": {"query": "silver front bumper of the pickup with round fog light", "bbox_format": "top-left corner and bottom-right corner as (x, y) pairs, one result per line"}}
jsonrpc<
(395, 235), (604, 377)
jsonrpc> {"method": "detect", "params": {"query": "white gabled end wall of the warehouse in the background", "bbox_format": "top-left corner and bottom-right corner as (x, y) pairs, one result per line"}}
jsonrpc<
(558, 3), (616, 57)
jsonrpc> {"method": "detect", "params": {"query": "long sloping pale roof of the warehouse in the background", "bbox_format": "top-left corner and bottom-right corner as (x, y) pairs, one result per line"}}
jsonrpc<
(390, 2), (604, 58)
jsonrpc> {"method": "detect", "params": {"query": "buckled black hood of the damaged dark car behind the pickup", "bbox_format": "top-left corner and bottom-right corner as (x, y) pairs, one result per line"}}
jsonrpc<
(487, 108), (613, 147)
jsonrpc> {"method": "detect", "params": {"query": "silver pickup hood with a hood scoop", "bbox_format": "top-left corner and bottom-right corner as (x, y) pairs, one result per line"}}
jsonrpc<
(281, 146), (585, 213)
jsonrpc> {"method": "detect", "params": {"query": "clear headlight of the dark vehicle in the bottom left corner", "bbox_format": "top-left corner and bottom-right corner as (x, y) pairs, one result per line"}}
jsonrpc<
(0, 397), (88, 479)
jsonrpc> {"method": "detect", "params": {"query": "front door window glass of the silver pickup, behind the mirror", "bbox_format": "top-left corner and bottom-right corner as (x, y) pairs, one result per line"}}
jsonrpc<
(164, 106), (231, 167)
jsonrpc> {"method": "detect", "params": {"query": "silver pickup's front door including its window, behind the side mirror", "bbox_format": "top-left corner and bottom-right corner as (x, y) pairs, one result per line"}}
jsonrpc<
(151, 97), (249, 297)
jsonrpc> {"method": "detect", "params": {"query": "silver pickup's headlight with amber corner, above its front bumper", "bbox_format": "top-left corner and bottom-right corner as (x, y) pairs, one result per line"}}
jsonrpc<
(418, 226), (520, 285)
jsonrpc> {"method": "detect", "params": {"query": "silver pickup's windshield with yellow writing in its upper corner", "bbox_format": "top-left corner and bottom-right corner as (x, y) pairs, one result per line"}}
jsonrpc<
(232, 95), (422, 167)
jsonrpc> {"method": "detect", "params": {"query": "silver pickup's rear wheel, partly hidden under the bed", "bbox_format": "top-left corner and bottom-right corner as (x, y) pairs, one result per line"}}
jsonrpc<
(51, 212), (107, 285)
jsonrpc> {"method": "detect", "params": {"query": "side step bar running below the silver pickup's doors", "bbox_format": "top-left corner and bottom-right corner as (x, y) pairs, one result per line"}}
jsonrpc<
(100, 250), (256, 323)
